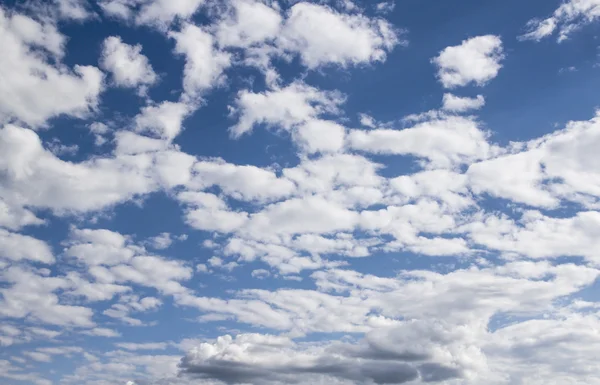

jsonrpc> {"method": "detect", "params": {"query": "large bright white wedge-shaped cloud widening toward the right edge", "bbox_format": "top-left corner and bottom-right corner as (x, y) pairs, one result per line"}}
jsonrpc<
(467, 109), (600, 208)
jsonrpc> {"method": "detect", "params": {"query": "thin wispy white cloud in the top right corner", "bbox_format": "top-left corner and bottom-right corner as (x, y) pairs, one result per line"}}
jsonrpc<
(519, 0), (600, 42)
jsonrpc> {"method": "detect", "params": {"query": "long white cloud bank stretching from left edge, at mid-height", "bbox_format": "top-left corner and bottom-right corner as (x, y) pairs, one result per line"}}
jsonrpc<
(0, 125), (194, 214)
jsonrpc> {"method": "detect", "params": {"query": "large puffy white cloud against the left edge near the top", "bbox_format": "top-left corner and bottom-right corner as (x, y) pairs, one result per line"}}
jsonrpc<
(0, 8), (104, 127)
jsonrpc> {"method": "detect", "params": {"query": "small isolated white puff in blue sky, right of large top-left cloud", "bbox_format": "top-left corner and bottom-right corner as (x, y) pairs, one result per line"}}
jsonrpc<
(100, 36), (158, 87)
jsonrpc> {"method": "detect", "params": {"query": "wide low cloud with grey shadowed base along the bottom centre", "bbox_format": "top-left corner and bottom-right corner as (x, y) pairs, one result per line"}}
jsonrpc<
(181, 334), (458, 384)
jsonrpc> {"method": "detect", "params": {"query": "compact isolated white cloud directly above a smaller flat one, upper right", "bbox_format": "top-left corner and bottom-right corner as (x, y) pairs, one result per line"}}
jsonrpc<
(431, 35), (504, 88)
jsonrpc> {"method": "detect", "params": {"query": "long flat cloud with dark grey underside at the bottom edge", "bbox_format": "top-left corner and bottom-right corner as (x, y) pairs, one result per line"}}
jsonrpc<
(180, 329), (462, 385)
